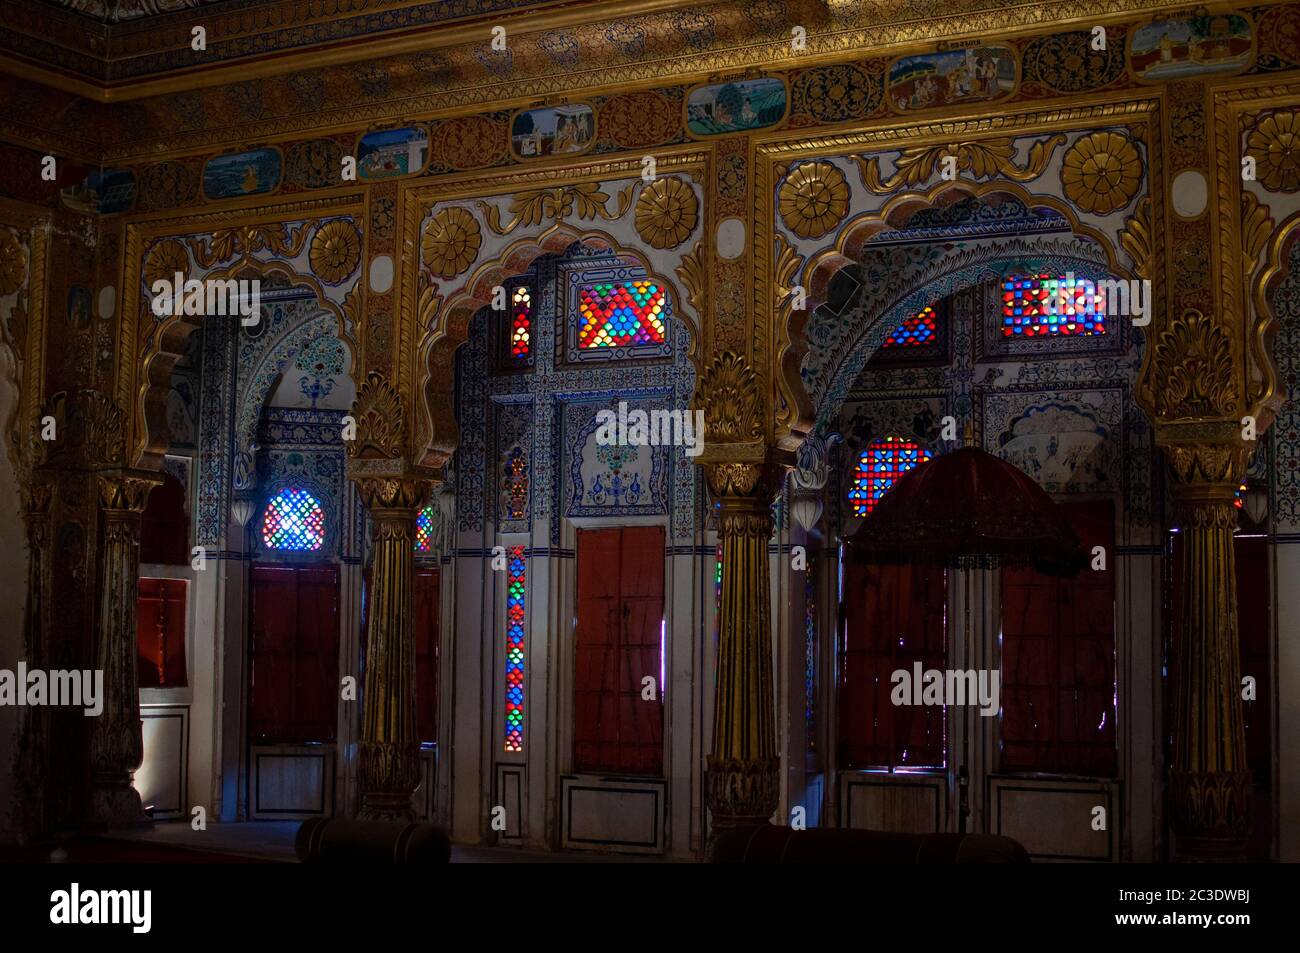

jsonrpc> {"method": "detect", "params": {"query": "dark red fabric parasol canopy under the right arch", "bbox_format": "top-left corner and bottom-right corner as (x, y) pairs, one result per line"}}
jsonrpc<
(849, 447), (1087, 576)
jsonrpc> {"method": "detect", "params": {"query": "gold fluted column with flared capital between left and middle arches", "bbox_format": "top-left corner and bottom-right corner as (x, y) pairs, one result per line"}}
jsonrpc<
(354, 477), (428, 822)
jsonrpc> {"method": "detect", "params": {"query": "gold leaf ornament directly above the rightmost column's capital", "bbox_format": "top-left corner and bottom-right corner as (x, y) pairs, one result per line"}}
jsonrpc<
(1152, 308), (1236, 417)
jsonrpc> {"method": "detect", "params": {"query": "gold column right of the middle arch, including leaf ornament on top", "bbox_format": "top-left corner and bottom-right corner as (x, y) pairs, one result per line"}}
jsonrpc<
(697, 352), (780, 831)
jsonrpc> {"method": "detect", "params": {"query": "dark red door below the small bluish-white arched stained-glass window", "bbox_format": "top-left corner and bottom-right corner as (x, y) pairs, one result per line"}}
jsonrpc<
(248, 566), (339, 744)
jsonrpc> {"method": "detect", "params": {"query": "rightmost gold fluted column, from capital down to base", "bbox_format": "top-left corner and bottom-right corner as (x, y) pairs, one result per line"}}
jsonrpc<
(1165, 442), (1252, 859)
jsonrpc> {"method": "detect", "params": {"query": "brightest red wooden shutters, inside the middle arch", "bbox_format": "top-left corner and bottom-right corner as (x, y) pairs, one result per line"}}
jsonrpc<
(573, 527), (664, 775)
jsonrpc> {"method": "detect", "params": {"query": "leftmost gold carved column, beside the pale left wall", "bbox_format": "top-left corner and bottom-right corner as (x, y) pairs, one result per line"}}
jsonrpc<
(90, 469), (161, 827)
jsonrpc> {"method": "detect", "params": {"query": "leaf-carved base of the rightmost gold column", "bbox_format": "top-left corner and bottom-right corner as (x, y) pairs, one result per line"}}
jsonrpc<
(1169, 771), (1253, 862)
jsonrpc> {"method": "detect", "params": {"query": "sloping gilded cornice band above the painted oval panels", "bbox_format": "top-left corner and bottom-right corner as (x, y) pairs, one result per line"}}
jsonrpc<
(0, 0), (1258, 163)
